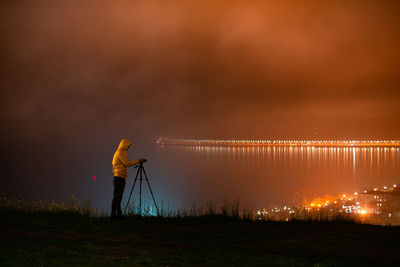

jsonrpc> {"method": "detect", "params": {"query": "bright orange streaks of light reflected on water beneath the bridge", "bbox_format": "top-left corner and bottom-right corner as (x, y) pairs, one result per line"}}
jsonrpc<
(182, 146), (400, 178)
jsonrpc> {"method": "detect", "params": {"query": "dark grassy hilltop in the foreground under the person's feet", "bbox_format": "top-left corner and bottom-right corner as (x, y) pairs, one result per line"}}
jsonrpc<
(0, 210), (400, 266)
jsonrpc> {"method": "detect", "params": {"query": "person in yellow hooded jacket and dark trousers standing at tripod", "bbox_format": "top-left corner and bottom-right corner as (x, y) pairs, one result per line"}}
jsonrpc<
(111, 138), (145, 218)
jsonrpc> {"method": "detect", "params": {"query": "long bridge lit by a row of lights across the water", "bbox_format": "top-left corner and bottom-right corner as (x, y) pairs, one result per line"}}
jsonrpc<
(157, 137), (400, 147)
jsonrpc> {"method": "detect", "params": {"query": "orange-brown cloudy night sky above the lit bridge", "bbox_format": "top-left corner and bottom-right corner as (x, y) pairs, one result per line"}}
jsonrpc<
(1, 1), (400, 140)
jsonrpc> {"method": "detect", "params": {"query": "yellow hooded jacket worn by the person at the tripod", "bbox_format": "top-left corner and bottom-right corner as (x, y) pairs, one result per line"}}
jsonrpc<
(112, 138), (139, 178)
